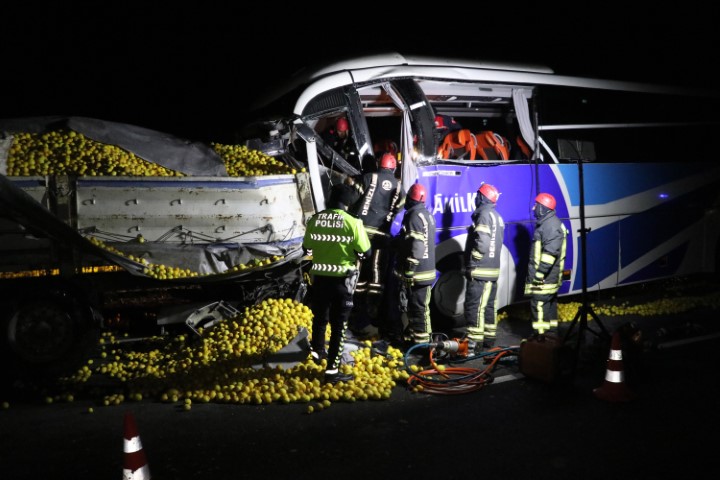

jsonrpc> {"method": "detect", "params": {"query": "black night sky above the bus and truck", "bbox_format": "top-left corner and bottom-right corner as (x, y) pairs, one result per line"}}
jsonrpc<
(0, 2), (718, 141)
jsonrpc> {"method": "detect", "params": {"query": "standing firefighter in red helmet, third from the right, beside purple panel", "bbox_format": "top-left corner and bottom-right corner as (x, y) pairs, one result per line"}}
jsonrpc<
(390, 183), (435, 345)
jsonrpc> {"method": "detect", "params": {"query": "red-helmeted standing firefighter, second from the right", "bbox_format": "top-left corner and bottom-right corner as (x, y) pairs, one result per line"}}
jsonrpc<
(461, 183), (505, 353)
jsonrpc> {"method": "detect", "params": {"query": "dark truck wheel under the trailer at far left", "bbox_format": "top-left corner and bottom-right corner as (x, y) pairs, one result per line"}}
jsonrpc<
(2, 299), (98, 377)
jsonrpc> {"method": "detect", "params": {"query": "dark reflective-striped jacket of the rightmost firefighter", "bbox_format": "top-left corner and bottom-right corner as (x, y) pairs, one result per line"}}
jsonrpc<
(525, 210), (568, 295)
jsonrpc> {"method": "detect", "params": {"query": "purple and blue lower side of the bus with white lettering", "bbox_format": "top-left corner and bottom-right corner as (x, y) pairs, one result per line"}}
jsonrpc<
(404, 163), (720, 310)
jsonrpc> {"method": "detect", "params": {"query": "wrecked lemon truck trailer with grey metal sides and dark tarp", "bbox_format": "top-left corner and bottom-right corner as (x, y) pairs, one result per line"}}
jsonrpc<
(0, 117), (315, 375)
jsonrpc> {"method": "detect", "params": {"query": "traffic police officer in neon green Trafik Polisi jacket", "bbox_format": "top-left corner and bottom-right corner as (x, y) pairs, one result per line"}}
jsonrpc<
(303, 183), (370, 383)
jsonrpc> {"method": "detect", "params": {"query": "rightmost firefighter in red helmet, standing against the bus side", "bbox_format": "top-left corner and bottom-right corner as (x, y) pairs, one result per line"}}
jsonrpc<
(525, 193), (568, 335)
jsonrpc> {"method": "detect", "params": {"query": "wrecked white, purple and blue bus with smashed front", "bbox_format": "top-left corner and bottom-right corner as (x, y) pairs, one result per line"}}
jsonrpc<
(243, 53), (720, 330)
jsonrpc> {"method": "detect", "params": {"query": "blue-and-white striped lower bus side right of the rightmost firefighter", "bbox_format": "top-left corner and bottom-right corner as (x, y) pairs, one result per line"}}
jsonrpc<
(552, 163), (720, 292)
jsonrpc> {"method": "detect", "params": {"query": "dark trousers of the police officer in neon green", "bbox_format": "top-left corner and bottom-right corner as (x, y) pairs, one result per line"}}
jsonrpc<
(310, 274), (357, 370)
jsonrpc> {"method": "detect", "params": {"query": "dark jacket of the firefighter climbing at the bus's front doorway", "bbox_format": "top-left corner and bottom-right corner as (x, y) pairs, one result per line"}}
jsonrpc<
(350, 168), (405, 237)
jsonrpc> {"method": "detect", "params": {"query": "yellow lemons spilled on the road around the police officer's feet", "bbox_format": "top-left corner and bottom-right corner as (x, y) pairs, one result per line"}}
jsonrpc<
(56, 298), (409, 410)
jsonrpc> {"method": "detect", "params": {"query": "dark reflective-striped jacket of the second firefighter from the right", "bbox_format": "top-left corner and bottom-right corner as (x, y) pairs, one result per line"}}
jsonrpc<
(465, 202), (505, 280)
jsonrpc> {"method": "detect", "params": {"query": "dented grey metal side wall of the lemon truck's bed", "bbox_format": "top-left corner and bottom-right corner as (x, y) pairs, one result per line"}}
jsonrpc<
(0, 173), (312, 276)
